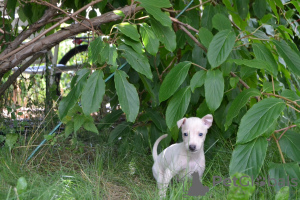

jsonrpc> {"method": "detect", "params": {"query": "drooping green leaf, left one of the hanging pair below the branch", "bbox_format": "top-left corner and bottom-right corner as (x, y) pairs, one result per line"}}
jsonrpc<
(81, 70), (105, 115)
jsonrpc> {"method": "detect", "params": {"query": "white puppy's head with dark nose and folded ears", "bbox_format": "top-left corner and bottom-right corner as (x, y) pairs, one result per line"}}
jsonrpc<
(177, 114), (213, 152)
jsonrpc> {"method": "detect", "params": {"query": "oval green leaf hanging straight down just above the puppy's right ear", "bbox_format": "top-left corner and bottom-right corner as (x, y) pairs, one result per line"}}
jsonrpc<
(204, 69), (224, 112)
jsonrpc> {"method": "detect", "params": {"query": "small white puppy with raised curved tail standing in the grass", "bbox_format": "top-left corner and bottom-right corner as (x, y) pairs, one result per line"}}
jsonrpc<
(152, 114), (213, 197)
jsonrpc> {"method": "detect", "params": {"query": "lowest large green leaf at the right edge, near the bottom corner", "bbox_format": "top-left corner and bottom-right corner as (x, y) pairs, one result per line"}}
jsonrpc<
(268, 163), (300, 191)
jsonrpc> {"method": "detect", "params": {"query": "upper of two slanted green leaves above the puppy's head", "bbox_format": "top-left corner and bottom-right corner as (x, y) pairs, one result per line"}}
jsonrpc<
(159, 61), (191, 102)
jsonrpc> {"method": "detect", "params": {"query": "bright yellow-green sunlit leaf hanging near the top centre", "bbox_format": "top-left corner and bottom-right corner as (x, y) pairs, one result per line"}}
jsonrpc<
(140, 23), (159, 56)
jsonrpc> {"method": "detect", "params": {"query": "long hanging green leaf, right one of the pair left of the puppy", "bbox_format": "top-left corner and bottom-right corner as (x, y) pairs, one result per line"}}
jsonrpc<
(115, 70), (140, 122)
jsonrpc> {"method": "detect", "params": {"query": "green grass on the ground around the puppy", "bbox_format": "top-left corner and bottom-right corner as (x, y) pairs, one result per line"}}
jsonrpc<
(0, 126), (296, 200)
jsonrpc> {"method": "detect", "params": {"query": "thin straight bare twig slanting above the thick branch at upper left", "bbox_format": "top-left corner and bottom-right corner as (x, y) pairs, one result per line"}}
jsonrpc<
(0, 0), (102, 60)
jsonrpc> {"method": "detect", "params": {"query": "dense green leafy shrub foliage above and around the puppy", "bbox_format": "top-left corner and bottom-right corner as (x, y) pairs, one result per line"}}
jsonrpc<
(0, 0), (300, 198)
